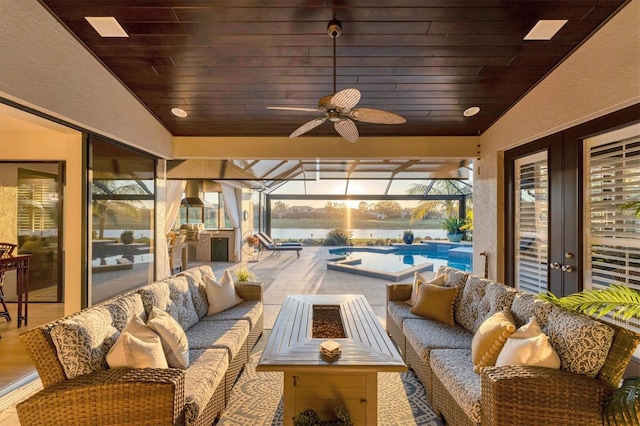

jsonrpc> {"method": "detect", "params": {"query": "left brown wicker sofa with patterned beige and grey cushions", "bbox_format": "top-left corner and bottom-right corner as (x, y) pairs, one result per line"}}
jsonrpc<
(17, 266), (263, 426)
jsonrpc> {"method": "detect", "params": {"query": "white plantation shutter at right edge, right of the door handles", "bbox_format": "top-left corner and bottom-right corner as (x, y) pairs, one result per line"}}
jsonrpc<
(585, 125), (640, 331)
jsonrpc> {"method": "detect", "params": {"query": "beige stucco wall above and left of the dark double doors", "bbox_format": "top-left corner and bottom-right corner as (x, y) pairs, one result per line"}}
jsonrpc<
(473, 0), (640, 280)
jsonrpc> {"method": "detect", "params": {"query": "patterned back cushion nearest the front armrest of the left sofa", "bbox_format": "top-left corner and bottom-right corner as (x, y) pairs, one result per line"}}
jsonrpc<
(51, 307), (120, 379)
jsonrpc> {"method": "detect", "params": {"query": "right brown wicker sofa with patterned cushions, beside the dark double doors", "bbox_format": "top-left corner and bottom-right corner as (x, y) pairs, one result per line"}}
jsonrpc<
(387, 267), (640, 426)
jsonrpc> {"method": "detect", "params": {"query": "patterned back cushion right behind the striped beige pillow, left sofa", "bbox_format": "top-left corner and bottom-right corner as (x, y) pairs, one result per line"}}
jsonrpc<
(138, 276), (200, 331)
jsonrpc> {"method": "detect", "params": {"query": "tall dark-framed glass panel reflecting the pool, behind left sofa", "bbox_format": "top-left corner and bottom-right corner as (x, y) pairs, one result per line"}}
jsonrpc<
(90, 139), (155, 304)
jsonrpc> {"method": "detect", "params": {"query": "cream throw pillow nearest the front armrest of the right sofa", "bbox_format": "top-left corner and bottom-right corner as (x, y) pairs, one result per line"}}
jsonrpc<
(496, 317), (560, 370)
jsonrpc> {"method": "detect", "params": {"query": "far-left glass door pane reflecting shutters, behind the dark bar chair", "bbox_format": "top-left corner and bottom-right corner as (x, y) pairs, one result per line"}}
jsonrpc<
(17, 163), (62, 302)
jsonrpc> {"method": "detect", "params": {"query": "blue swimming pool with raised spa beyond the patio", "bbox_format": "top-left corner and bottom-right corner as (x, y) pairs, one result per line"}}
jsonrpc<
(327, 241), (473, 281)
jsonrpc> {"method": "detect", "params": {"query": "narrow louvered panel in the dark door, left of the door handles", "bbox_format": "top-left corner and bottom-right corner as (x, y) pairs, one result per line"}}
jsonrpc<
(514, 151), (549, 293)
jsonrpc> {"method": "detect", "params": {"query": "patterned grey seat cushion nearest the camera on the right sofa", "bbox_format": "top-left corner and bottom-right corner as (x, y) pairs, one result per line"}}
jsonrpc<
(429, 349), (481, 424)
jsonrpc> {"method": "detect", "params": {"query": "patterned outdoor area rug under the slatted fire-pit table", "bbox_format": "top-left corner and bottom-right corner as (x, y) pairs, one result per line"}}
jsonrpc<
(216, 352), (444, 426)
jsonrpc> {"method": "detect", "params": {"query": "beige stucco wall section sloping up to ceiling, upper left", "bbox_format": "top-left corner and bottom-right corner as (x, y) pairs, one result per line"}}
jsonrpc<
(0, 0), (172, 158)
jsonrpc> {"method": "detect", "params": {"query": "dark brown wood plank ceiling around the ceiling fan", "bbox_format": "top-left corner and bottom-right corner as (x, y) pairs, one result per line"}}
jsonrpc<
(40, 0), (625, 136)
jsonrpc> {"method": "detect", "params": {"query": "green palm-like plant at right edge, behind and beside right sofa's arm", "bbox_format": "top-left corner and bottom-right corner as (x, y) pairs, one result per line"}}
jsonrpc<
(538, 284), (640, 425)
